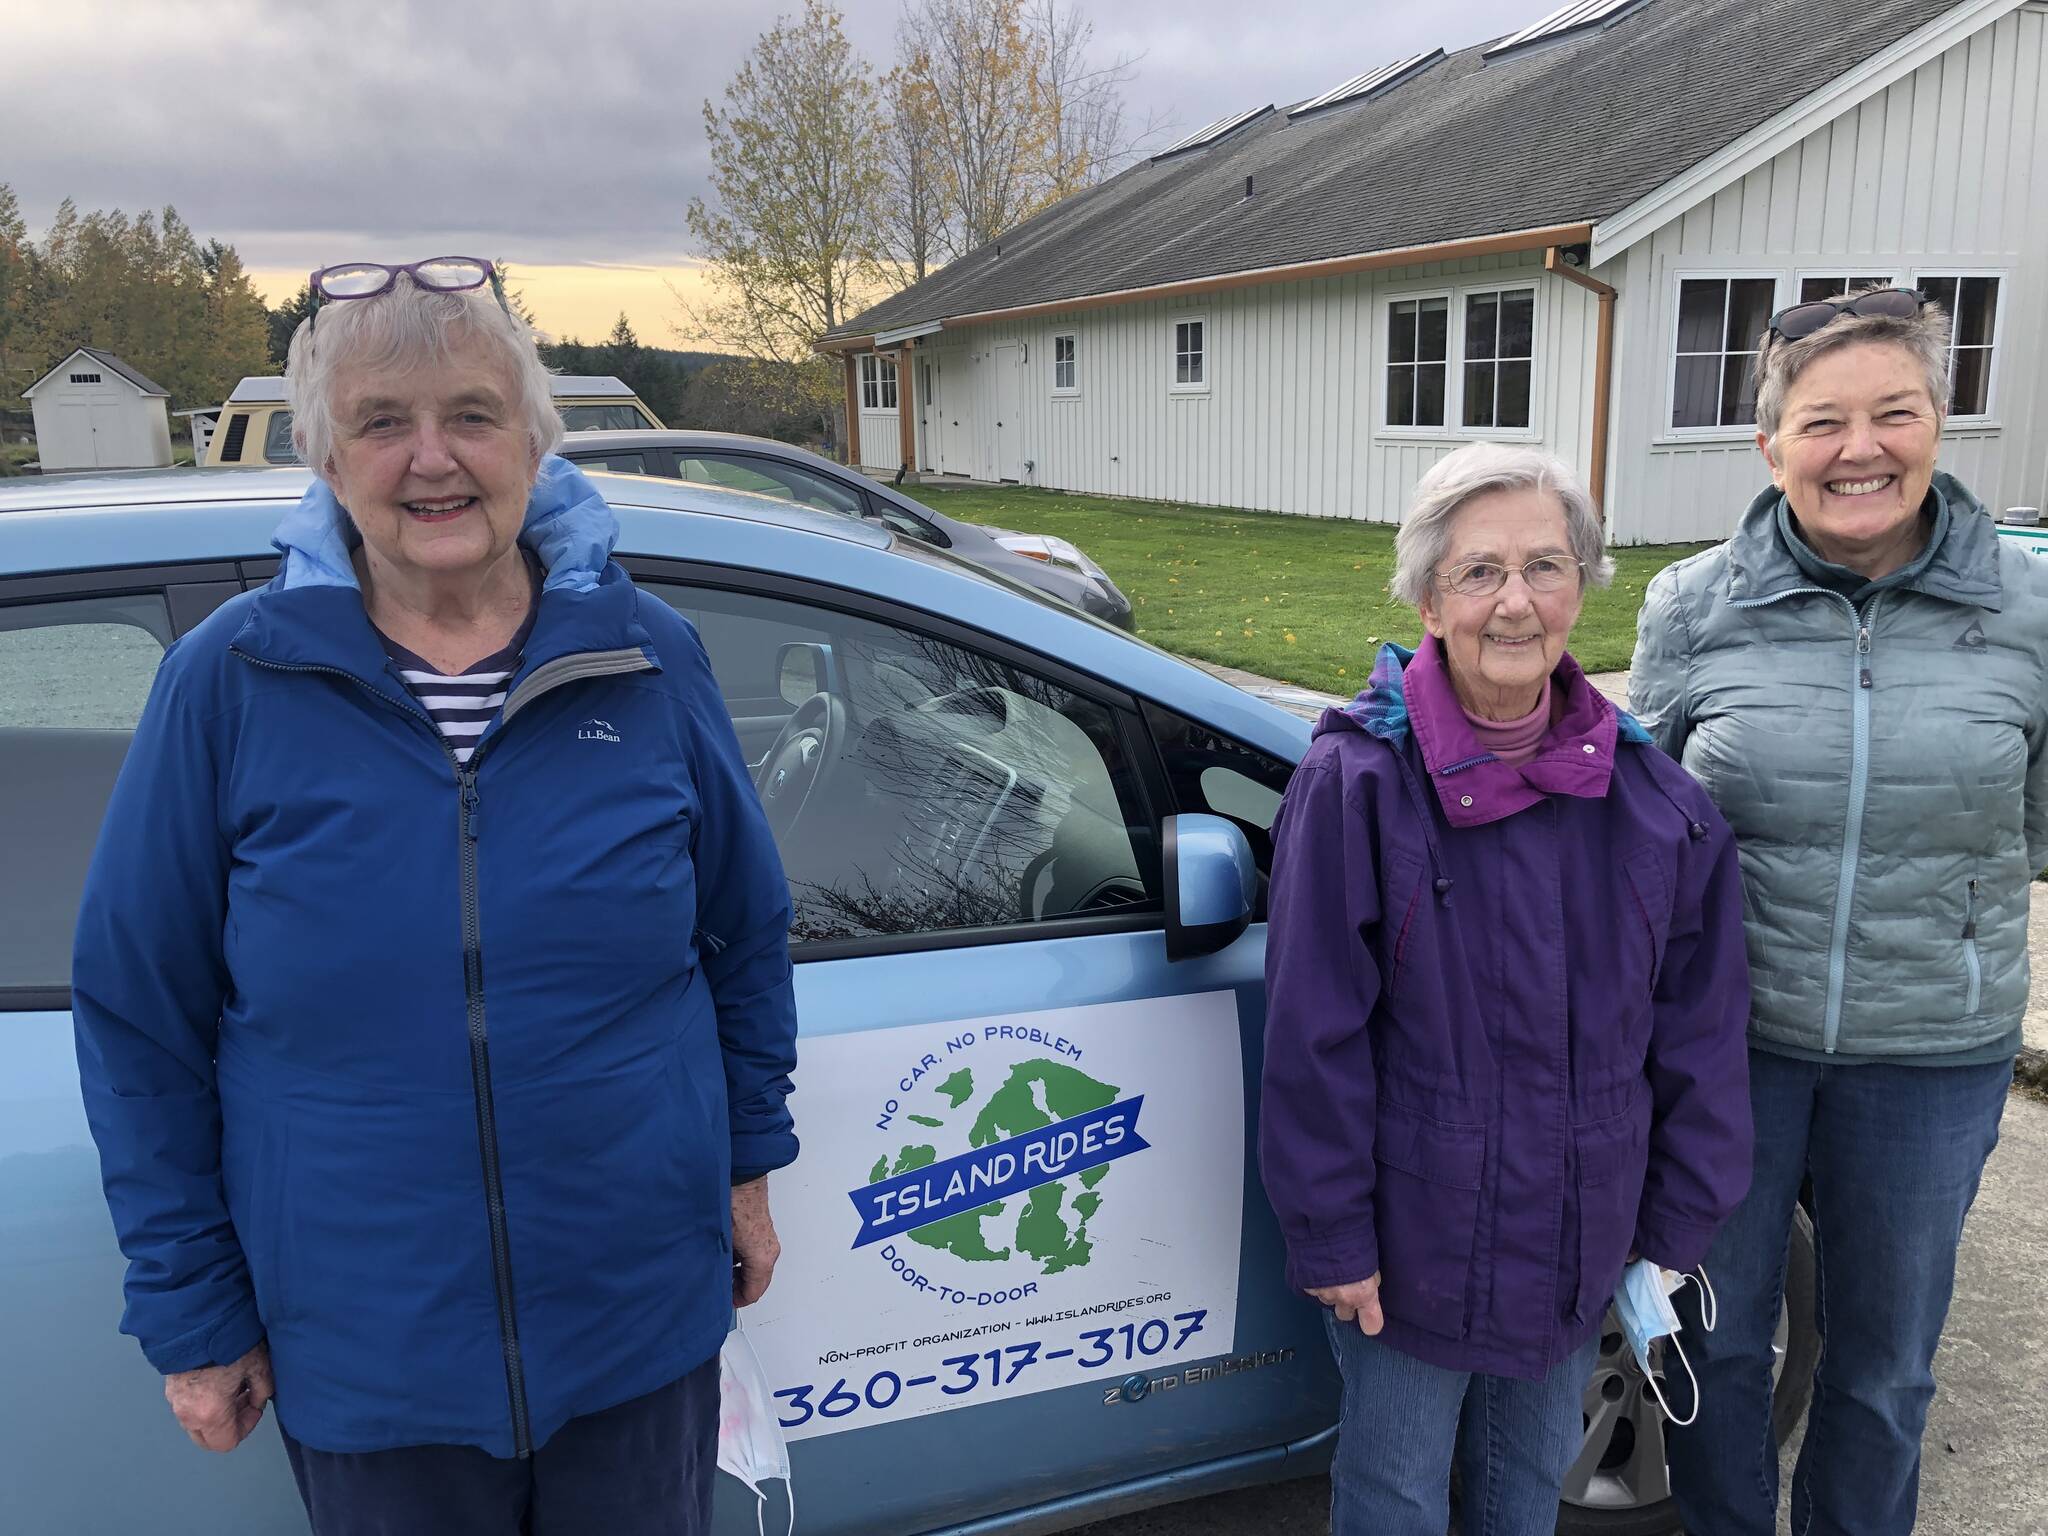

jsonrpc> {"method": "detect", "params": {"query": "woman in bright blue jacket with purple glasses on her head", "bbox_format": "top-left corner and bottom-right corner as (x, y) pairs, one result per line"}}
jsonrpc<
(74, 258), (797, 1536)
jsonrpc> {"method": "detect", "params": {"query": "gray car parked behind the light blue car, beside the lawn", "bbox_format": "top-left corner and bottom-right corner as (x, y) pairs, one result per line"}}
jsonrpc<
(559, 432), (1133, 629)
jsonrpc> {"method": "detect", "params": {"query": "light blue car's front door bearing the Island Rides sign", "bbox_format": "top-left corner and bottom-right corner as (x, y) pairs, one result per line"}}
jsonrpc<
(629, 561), (1335, 1536)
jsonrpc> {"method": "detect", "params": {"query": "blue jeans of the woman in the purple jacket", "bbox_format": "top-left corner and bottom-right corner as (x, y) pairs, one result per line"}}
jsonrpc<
(1323, 1311), (1599, 1536)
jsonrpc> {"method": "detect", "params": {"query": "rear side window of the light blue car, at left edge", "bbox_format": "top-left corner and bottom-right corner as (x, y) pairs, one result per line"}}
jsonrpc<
(0, 592), (172, 989)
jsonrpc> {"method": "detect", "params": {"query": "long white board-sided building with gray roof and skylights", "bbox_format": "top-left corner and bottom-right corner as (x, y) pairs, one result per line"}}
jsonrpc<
(821, 0), (2048, 543)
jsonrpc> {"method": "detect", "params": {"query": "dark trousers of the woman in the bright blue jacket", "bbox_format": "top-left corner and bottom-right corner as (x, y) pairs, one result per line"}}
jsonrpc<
(285, 1356), (719, 1536)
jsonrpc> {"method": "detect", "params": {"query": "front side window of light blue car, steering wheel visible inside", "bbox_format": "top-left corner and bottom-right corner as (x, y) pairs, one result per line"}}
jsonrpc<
(643, 582), (1159, 944)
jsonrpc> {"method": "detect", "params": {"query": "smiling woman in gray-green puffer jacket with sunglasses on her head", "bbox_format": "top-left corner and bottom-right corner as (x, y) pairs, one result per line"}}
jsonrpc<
(1630, 289), (2048, 1536)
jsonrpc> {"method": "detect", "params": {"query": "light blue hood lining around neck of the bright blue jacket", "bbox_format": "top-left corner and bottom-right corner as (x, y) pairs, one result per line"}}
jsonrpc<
(270, 453), (618, 592)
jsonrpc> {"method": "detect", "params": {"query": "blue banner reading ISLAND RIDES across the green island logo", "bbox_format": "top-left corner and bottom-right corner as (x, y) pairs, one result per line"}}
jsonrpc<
(846, 1094), (1149, 1247)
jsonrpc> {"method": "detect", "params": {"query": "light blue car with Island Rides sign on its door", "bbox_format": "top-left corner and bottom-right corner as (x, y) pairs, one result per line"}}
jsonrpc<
(0, 469), (1794, 1536)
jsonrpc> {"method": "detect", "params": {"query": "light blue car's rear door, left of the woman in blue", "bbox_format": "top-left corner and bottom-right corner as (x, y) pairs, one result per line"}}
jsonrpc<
(0, 561), (305, 1536)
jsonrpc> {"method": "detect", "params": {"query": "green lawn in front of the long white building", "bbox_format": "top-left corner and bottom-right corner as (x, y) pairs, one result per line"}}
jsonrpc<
(907, 485), (1702, 694)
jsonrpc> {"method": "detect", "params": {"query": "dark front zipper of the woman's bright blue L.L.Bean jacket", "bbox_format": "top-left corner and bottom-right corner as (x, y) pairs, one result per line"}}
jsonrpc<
(236, 649), (653, 1460)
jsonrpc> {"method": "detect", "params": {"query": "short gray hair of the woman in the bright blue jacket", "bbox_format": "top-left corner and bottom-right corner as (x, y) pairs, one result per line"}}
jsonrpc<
(285, 274), (561, 473)
